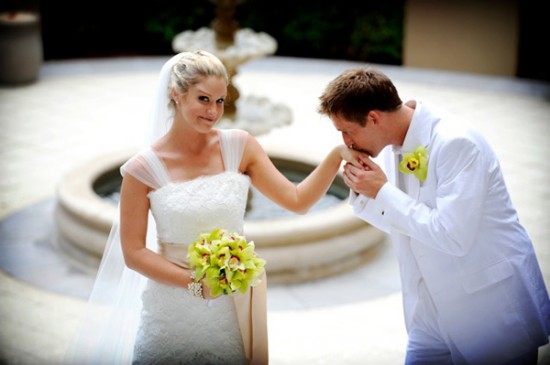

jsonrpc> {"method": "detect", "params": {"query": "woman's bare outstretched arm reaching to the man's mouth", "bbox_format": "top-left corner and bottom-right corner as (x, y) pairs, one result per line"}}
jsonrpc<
(241, 135), (358, 214)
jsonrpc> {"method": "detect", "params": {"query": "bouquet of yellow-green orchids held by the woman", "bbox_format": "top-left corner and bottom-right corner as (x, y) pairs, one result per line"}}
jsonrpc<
(187, 229), (265, 297)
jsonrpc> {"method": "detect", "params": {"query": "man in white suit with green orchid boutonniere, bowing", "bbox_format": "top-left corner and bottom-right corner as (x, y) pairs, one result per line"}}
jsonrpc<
(319, 68), (550, 365)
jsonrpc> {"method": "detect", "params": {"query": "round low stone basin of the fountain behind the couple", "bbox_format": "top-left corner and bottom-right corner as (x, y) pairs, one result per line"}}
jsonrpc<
(55, 149), (385, 284)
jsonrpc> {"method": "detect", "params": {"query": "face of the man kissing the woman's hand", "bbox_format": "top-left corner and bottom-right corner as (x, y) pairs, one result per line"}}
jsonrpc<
(330, 115), (383, 157)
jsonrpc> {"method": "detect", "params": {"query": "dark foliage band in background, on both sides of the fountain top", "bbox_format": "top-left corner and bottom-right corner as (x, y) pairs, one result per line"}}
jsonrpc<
(41, 0), (404, 64)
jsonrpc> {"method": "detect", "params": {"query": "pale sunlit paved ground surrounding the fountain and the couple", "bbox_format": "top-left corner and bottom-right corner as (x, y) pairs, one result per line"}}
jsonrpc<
(0, 57), (550, 365)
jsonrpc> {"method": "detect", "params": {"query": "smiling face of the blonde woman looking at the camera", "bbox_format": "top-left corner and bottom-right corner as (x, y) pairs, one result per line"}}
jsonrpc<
(176, 76), (227, 131)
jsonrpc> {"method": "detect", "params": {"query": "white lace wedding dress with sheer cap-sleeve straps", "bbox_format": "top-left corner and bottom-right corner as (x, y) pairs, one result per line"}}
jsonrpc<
(121, 130), (265, 365)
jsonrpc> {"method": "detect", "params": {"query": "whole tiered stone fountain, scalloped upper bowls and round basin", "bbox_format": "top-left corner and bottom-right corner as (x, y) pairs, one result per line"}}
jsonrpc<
(55, 0), (385, 284)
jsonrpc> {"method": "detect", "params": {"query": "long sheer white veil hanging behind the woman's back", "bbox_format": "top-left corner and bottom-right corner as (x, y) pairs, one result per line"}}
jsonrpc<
(64, 54), (182, 365)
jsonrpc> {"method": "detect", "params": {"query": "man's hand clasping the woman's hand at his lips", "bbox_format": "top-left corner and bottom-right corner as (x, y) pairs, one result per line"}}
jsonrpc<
(344, 154), (388, 198)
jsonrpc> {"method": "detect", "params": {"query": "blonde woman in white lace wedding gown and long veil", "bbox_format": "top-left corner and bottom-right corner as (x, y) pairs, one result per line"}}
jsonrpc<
(64, 51), (362, 364)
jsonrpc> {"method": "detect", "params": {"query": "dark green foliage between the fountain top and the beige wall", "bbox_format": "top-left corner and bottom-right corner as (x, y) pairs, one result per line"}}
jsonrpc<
(237, 0), (404, 64)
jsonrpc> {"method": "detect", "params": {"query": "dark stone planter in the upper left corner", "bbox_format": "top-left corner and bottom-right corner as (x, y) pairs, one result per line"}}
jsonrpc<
(0, 11), (43, 84)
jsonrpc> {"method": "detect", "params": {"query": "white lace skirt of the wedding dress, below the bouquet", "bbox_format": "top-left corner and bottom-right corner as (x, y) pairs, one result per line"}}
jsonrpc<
(133, 280), (247, 365)
